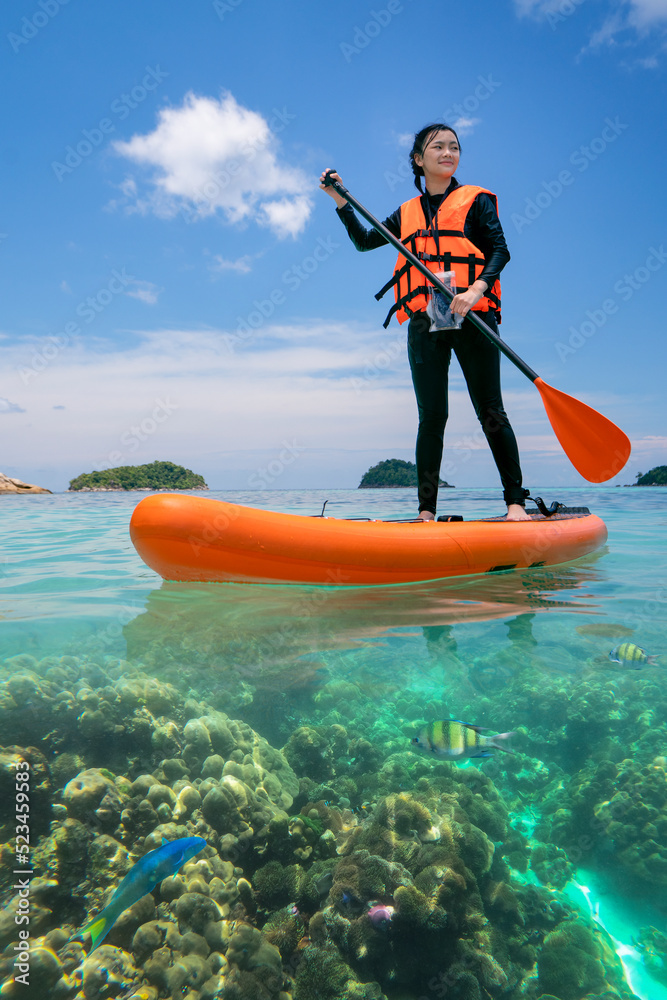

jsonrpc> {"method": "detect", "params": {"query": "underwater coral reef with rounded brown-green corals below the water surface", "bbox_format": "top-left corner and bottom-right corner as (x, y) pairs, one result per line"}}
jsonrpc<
(0, 624), (667, 1000)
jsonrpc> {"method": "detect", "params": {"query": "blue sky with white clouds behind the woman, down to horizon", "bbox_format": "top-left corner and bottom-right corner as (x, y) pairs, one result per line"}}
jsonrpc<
(0, 0), (667, 490)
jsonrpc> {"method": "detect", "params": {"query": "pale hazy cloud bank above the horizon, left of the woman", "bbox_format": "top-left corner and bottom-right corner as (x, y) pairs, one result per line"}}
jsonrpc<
(0, 323), (414, 489)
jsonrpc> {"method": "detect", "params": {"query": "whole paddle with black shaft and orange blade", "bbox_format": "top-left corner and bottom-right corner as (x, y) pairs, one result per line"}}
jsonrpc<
(324, 171), (631, 483)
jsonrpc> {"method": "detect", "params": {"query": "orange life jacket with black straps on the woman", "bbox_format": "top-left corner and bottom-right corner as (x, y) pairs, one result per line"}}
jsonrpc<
(375, 184), (500, 329)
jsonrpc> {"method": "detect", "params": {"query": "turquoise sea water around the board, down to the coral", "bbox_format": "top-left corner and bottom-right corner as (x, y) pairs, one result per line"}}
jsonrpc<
(0, 486), (667, 1000)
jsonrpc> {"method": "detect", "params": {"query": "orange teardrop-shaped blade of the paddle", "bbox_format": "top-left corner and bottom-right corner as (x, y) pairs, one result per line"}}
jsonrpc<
(534, 377), (631, 483)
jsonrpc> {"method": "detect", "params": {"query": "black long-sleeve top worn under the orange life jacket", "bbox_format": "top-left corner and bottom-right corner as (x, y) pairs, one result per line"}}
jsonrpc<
(336, 177), (510, 306)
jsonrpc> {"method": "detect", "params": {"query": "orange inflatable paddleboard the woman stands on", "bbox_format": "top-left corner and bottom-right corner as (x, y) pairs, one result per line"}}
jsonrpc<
(130, 493), (607, 587)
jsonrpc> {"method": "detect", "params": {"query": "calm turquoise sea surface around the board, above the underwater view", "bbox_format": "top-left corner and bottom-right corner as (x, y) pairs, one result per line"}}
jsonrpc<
(0, 488), (667, 668)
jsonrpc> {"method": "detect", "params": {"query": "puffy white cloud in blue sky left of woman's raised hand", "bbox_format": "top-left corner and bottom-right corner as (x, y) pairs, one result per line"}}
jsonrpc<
(110, 93), (313, 238)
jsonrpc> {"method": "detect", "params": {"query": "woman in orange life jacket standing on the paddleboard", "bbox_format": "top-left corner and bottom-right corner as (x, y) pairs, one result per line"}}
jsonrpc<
(320, 123), (530, 521)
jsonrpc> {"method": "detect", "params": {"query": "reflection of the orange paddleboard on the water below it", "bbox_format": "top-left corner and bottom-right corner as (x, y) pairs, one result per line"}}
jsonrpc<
(123, 553), (601, 741)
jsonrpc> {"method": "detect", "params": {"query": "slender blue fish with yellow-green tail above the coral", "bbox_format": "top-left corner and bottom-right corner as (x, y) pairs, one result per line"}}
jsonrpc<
(80, 837), (206, 955)
